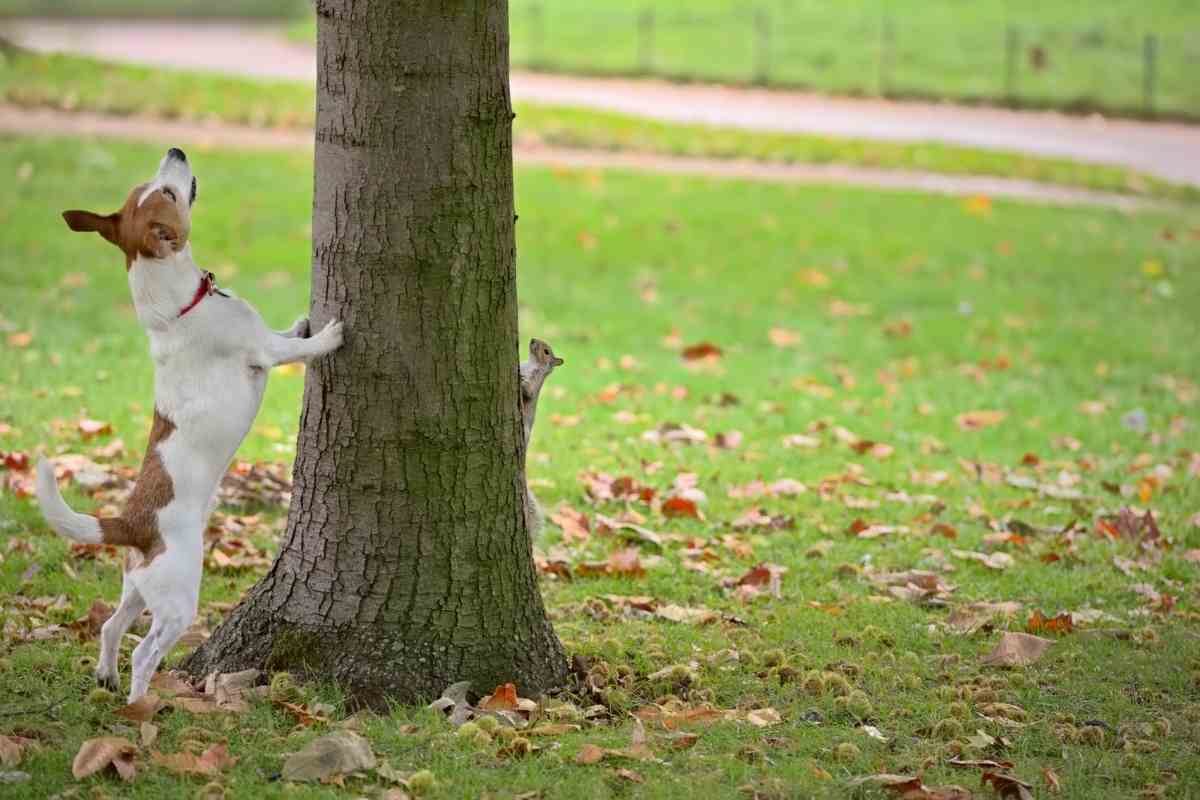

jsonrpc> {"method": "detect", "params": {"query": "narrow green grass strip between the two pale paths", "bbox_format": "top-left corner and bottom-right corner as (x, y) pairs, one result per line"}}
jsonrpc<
(0, 53), (1200, 201)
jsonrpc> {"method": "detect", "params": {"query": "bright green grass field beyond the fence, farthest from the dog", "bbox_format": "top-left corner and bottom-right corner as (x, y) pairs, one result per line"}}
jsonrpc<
(292, 0), (1200, 119)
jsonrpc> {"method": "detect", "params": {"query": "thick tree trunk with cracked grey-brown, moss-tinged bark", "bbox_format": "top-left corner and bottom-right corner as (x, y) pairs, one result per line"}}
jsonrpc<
(185, 0), (568, 705)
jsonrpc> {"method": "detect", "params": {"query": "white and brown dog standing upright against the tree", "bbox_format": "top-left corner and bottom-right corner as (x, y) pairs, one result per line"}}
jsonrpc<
(37, 148), (342, 703)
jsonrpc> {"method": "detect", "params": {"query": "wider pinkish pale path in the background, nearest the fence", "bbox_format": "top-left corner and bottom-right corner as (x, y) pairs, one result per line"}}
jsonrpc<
(0, 20), (1200, 186)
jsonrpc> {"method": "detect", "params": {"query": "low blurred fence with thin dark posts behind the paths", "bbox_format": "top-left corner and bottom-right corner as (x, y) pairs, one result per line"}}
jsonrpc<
(510, 1), (1200, 119)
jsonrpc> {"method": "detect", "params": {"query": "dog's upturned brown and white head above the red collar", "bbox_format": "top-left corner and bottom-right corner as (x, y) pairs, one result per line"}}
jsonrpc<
(62, 148), (196, 270)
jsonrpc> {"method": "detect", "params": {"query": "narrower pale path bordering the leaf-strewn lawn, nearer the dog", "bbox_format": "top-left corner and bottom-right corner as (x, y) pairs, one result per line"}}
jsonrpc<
(0, 104), (1170, 211)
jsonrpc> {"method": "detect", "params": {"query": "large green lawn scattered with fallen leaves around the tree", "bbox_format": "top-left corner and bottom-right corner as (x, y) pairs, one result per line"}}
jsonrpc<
(0, 138), (1200, 800)
